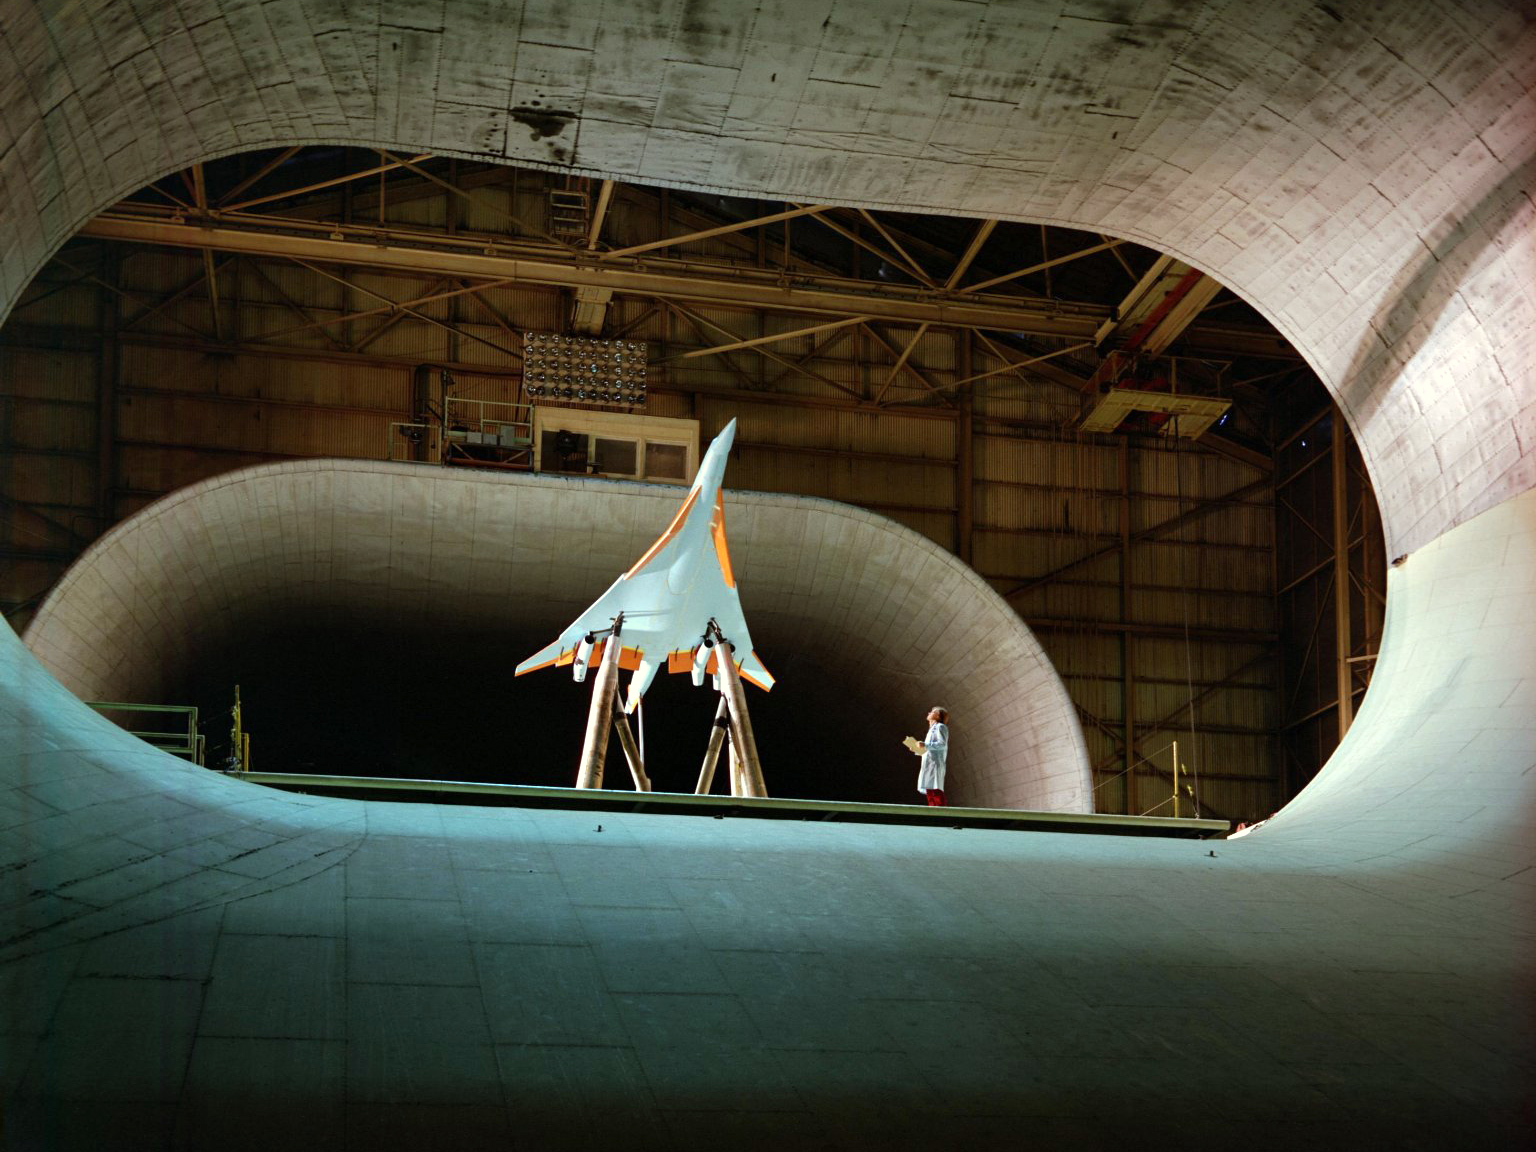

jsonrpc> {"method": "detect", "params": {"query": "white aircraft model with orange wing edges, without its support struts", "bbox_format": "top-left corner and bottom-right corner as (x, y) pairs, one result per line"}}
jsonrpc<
(515, 419), (774, 713)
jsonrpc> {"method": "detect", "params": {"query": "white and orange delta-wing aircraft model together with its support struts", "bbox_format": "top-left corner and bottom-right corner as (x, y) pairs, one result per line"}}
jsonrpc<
(515, 419), (774, 796)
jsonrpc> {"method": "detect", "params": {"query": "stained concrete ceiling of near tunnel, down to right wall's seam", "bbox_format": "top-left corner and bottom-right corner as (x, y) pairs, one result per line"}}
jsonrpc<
(0, 0), (1536, 554)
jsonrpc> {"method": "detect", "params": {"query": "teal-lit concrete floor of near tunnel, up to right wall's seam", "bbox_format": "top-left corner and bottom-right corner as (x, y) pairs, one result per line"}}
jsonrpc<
(0, 496), (1536, 1149)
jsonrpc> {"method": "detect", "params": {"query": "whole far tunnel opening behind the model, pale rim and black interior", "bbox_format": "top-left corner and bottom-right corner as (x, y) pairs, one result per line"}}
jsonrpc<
(26, 459), (1089, 811)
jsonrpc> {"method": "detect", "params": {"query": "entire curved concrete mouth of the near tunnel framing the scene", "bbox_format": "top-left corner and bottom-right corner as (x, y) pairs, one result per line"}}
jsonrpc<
(0, 0), (1536, 1147)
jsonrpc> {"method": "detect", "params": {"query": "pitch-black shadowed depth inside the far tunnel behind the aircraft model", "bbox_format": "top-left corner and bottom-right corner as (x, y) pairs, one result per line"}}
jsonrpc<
(179, 613), (921, 803)
